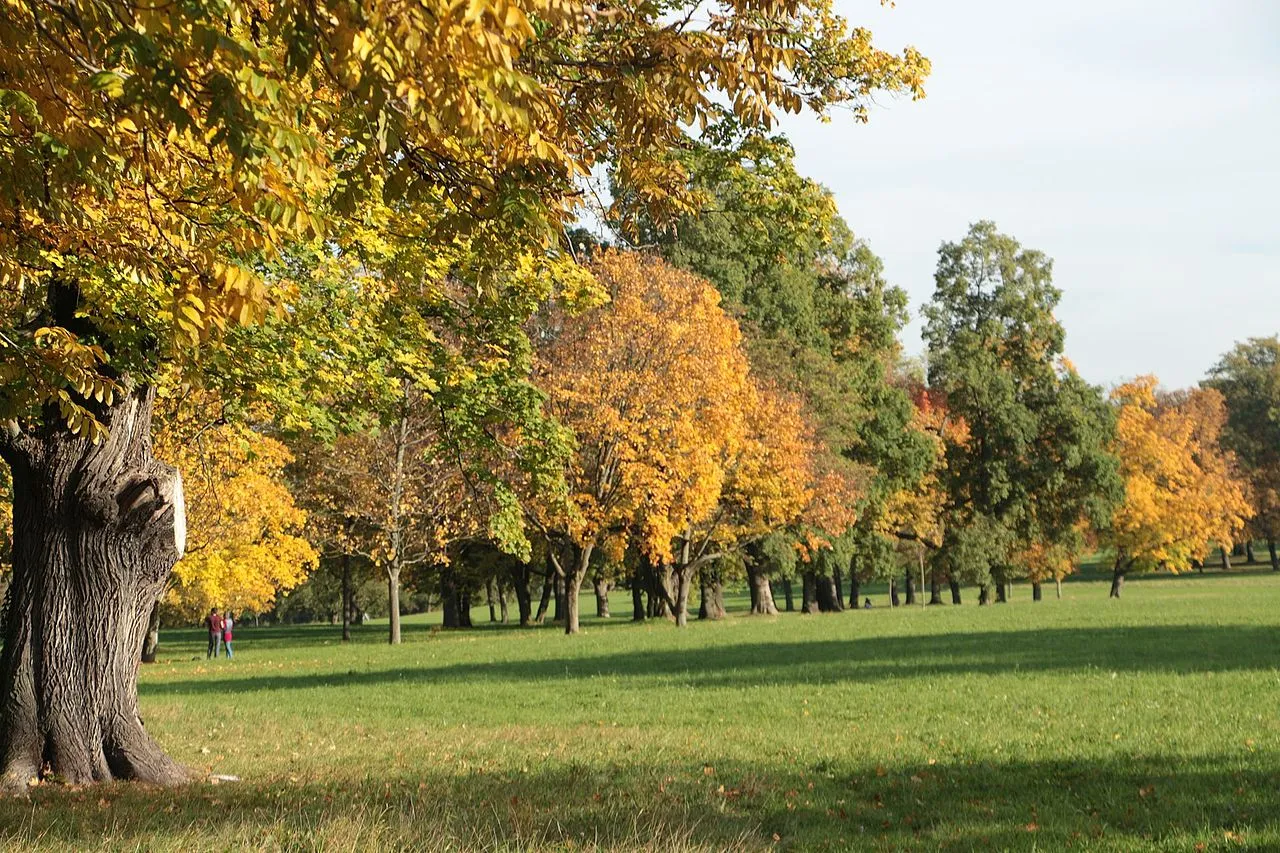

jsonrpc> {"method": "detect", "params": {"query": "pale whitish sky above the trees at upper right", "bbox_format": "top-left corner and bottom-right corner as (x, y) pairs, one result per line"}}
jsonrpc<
(782, 0), (1280, 387)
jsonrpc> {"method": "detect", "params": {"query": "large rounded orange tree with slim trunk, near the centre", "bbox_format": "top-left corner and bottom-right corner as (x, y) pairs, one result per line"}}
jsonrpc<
(536, 251), (750, 634)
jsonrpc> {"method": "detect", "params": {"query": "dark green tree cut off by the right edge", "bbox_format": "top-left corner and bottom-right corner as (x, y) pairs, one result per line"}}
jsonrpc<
(1204, 337), (1280, 563)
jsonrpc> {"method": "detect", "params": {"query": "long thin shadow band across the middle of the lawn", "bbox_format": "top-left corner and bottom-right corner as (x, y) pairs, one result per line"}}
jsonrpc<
(138, 625), (1277, 695)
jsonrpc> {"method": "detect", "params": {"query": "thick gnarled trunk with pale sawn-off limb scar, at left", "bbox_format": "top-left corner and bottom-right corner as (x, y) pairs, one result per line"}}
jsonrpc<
(0, 383), (188, 793)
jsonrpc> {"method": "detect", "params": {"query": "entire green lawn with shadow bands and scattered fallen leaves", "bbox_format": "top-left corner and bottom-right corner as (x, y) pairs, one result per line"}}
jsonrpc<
(0, 570), (1280, 850)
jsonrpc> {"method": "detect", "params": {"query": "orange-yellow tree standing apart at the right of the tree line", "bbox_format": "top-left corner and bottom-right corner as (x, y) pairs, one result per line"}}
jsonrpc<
(1106, 377), (1252, 598)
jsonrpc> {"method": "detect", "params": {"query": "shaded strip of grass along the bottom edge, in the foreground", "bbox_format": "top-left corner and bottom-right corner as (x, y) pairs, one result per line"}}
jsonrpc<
(0, 753), (1280, 850)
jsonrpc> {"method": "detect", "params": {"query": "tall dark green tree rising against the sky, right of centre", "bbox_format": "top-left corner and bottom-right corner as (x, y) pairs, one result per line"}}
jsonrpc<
(924, 222), (1119, 603)
